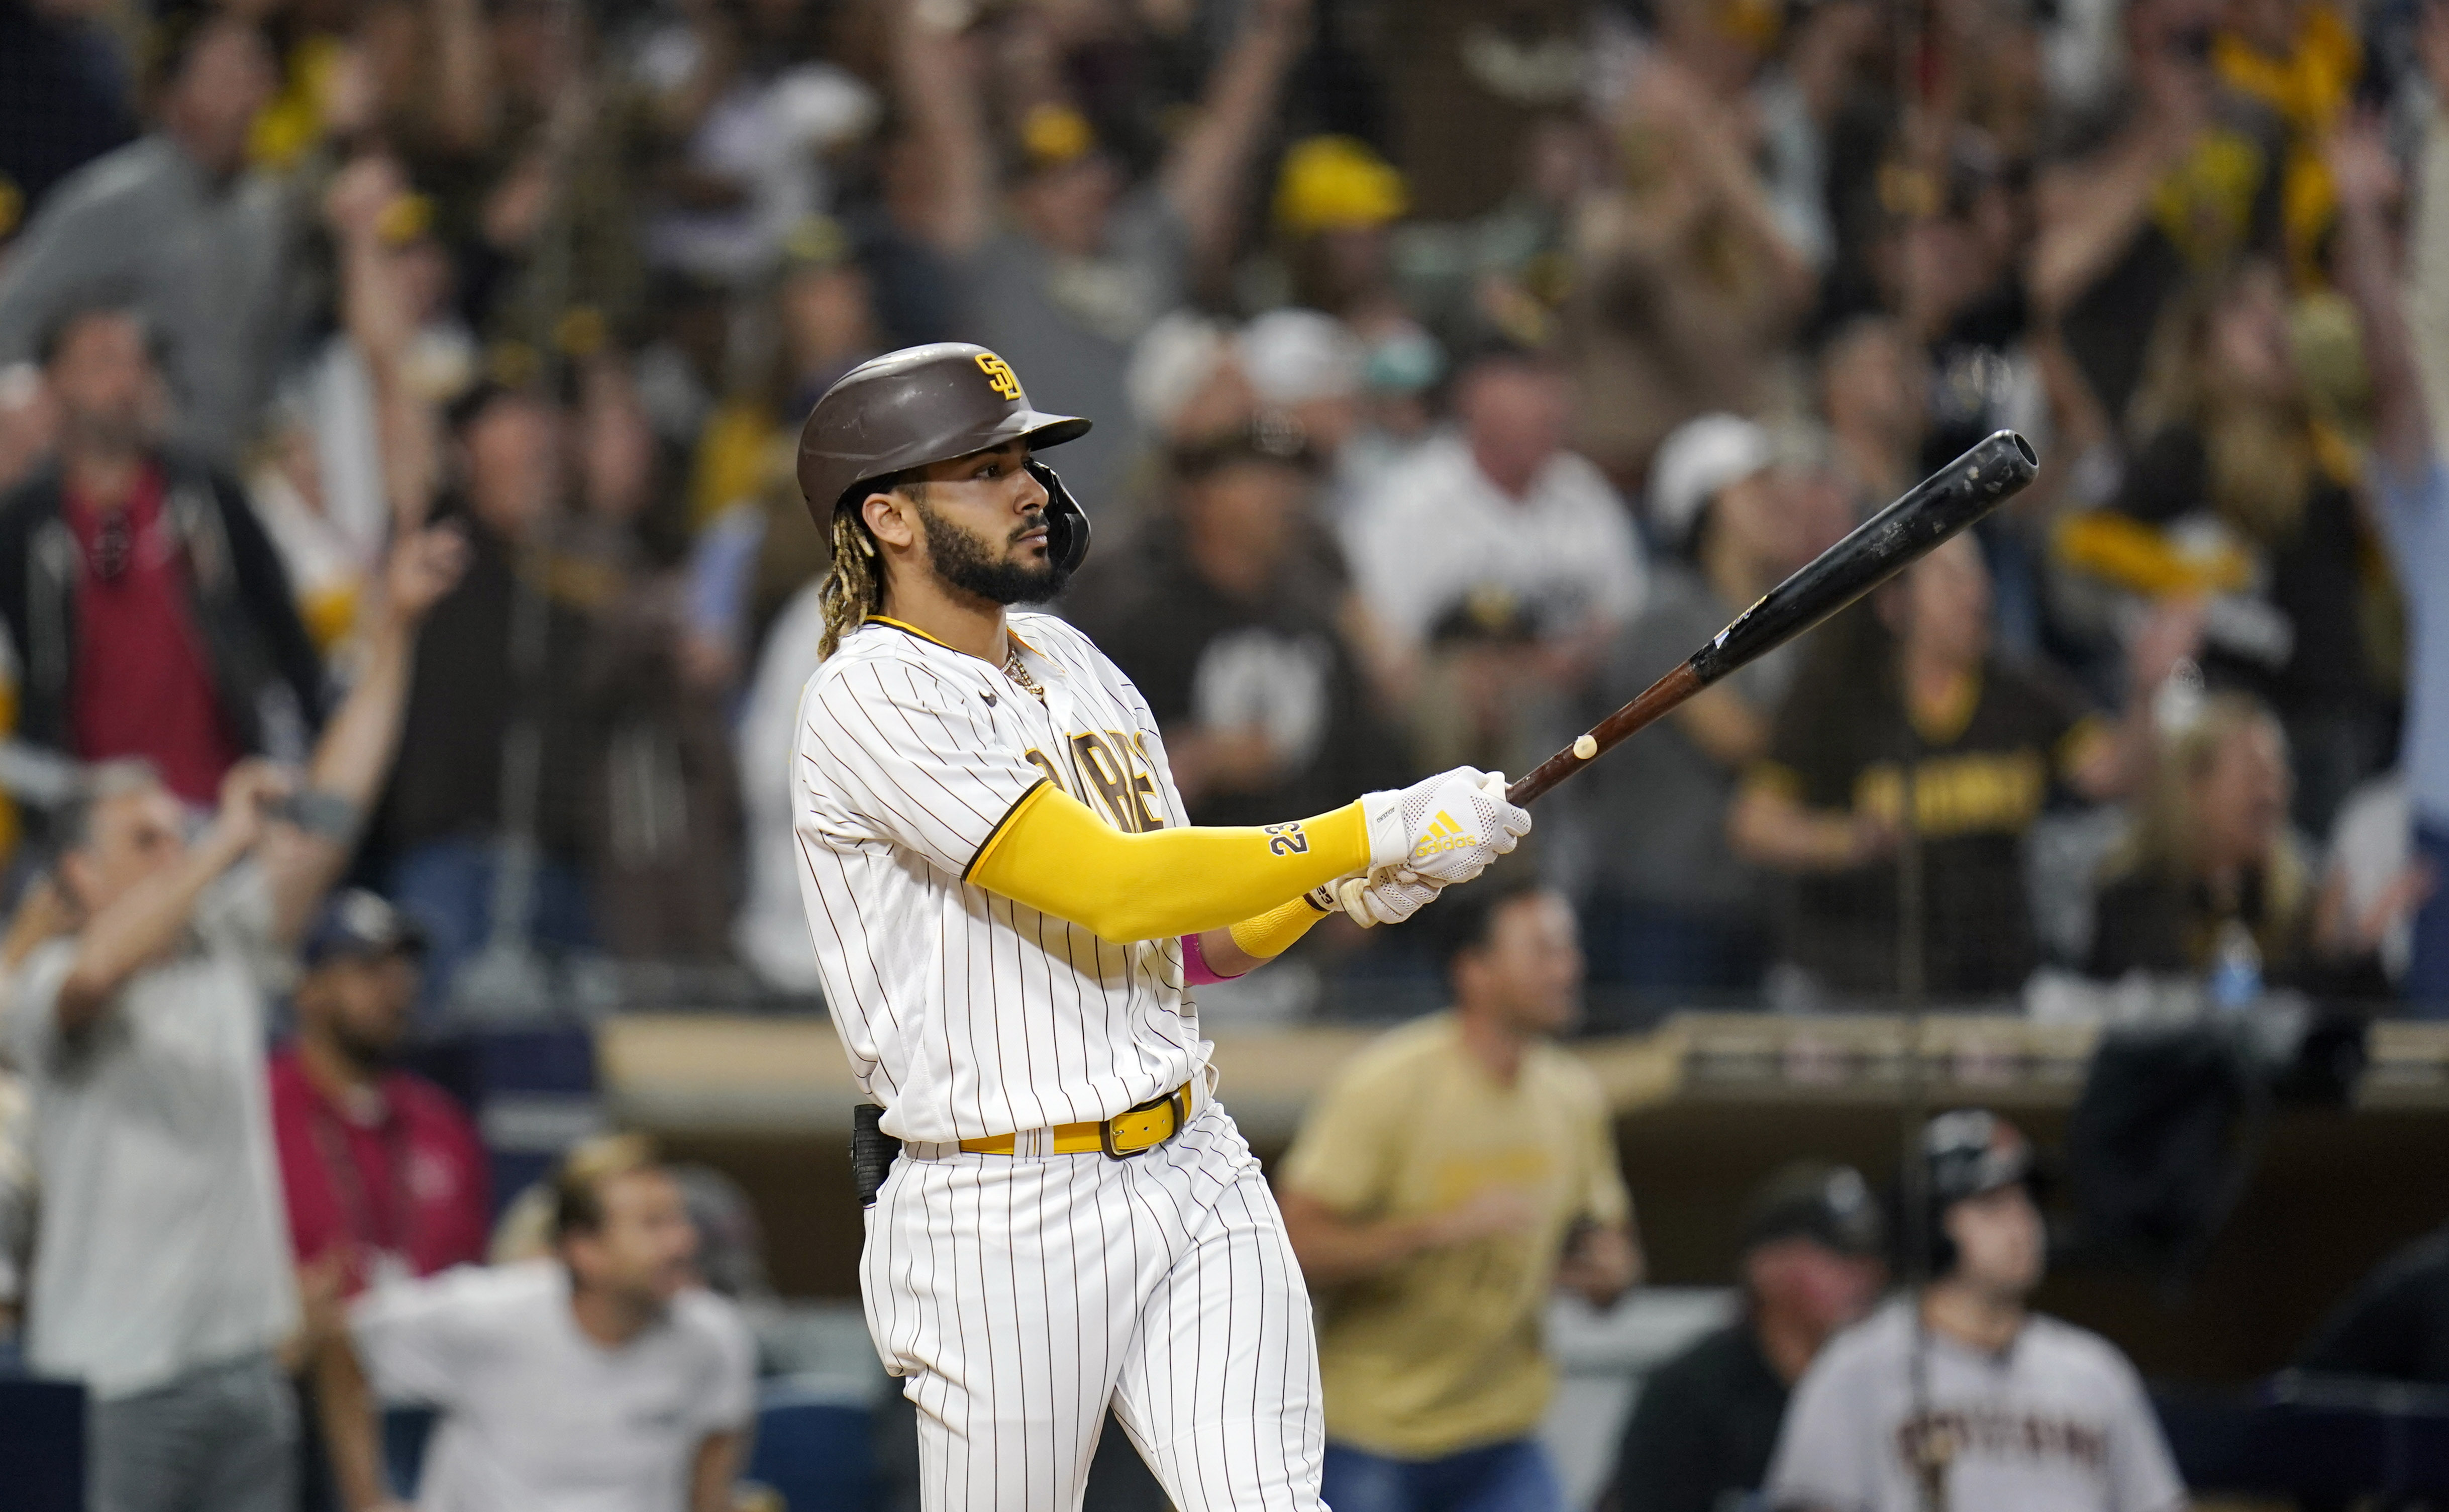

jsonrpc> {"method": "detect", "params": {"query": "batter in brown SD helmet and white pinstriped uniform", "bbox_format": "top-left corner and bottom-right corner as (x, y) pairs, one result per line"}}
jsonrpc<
(791, 343), (1530, 1512)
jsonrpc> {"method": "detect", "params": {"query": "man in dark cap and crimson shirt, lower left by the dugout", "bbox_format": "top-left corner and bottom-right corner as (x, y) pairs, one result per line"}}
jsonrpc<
(272, 889), (490, 1291)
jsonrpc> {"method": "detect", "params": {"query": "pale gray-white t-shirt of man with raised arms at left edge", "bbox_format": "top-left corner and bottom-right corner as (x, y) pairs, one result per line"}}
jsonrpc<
(8, 863), (296, 1399)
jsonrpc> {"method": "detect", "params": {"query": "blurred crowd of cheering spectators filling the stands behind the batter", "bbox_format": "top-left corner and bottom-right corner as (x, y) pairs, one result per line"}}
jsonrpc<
(0, 0), (2449, 1012)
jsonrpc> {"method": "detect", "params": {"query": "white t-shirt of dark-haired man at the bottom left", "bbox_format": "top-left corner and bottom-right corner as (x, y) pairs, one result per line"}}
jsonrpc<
(348, 1260), (757, 1512)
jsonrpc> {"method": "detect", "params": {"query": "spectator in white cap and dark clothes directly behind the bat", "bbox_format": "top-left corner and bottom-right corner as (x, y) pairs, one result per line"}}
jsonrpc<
(1582, 414), (1847, 990)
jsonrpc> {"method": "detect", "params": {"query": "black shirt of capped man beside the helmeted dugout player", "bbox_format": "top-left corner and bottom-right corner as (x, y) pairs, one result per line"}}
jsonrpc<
(1614, 1319), (1785, 1512)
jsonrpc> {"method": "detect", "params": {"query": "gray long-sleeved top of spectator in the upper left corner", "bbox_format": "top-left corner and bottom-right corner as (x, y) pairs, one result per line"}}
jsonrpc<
(0, 137), (291, 466)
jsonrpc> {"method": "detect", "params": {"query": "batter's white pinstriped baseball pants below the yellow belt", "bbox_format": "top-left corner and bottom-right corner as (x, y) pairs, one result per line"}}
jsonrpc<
(860, 1105), (1325, 1512)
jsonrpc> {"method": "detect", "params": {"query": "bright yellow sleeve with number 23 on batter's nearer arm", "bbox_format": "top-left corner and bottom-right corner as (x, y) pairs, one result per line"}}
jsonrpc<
(967, 782), (1369, 953)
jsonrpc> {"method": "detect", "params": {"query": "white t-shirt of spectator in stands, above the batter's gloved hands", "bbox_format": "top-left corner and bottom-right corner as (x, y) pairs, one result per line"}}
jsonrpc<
(1345, 434), (1648, 645)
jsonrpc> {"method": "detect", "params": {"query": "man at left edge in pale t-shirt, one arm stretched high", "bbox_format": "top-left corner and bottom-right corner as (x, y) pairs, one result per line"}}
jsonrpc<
(0, 527), (465, 1512)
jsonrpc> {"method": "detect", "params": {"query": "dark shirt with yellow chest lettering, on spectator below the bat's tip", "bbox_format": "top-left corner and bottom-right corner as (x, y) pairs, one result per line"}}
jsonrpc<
(1751, 620), (2106, 997)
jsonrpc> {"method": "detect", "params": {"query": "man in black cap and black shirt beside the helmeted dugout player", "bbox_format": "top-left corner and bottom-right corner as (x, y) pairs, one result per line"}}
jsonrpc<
(1614, 1162), (1888, 1512)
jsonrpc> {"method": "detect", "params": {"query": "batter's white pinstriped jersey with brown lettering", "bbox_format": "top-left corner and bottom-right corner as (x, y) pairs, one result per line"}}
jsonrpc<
(791, 613), (1210, 1142)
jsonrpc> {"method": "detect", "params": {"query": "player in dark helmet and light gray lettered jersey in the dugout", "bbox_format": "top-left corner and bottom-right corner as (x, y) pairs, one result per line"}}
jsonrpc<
(1766, 1107), (2185, 1512)
